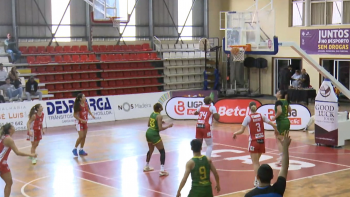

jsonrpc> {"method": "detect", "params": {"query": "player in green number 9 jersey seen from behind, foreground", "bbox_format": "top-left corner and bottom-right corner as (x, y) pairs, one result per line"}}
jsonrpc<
(176, 139), (220, 197)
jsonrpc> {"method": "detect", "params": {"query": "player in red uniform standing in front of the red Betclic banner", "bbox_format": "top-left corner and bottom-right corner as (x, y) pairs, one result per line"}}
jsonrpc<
(194, 96), (220, 158)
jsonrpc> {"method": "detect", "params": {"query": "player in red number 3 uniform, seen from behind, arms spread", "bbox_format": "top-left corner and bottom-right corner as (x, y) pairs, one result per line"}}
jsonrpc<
(233, 102), (277, 187)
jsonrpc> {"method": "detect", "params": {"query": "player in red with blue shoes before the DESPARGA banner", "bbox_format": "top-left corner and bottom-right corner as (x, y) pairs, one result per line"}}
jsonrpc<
(72, 93), (95, 157)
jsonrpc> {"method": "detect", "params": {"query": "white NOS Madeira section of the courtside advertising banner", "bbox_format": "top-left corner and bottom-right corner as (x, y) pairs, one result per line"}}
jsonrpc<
(111, 92), (169, 120)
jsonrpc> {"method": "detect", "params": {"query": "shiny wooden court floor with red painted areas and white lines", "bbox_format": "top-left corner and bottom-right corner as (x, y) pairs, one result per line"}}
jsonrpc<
(4, 100), (350, 197)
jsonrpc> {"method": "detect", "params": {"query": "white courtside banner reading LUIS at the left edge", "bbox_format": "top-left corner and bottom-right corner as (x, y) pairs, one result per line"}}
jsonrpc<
(0, 101), (47, 131)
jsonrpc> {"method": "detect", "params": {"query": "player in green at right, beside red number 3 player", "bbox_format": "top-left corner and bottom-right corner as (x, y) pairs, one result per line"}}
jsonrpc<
(271, 90), (292, 166)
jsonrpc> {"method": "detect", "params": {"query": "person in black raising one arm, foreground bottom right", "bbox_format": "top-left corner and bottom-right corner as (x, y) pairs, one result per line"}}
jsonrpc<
(245, 131), (291, 197)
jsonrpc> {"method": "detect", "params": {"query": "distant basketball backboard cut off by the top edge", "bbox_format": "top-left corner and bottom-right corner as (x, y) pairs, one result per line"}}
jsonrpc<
(92, 0), (134, 22)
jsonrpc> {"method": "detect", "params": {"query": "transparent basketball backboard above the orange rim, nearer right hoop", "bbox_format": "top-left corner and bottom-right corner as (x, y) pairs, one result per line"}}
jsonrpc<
(221, 9), (275, 51)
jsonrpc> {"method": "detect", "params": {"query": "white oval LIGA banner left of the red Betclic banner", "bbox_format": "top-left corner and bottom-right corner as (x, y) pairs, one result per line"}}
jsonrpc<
(165, 97), (204, 120)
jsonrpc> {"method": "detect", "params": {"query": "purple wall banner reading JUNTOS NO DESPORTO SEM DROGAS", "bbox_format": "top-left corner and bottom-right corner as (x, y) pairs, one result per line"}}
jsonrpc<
(300, 29), (350, 55)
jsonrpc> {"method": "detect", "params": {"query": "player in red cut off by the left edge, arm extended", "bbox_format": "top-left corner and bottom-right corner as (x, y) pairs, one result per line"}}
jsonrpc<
(0, 123), (37, 197)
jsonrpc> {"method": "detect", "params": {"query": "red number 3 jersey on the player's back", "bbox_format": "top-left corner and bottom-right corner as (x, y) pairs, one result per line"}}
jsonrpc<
(249, 113), (265, 141)
